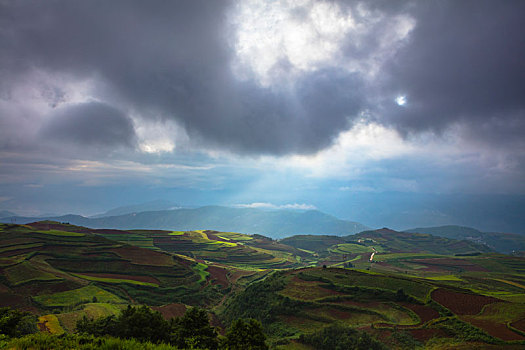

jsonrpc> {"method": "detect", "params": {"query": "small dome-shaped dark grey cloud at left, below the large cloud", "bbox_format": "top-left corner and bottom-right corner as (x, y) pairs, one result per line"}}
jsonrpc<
(41, 102), (136, 147)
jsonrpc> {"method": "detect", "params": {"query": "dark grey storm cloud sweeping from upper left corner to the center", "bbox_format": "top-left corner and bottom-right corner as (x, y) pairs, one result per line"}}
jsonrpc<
(0, 1), (362, 154)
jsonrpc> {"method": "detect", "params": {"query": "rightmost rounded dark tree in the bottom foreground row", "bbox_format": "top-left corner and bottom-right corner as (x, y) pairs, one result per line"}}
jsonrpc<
(222, 318), (268, 350)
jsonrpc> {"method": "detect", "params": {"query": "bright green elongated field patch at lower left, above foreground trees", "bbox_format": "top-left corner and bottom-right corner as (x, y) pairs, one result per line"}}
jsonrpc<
(33, 284), (124, 307)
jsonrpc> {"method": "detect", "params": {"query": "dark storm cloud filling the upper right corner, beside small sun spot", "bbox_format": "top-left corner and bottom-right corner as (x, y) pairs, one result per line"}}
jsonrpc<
(376, 1), (525, 147)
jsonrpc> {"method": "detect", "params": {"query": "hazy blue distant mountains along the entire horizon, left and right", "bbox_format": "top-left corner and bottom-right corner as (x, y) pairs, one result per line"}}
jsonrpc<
(0, 205), (525, 253)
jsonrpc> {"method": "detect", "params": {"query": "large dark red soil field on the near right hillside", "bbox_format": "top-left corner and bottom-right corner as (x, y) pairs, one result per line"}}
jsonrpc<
(431, 288), (502, 315)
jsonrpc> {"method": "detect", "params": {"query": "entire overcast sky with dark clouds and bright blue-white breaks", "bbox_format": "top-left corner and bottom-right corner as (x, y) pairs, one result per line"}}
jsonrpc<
(0, 0), (525, 232)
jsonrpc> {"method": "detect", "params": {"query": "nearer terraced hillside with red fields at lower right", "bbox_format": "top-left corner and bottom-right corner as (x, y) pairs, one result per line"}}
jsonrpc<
(219, 262), (525, 349)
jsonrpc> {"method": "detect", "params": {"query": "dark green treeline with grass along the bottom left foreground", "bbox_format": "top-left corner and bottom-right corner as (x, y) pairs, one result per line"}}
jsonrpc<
(0, 306), (268, 350)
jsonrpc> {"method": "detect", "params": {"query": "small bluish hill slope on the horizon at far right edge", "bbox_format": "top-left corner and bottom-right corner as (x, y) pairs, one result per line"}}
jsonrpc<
(405, 225), (525, 253)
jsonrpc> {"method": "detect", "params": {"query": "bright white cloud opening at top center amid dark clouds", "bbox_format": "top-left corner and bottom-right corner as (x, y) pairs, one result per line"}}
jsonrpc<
(231, 0), (415, 86)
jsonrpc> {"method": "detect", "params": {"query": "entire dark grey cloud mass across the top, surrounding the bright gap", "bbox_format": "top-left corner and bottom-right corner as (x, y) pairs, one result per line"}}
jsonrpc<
(0, 1), (525, 159)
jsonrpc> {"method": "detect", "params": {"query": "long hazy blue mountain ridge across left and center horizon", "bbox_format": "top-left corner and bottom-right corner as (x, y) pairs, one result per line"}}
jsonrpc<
(0, 206), (369, 238)
